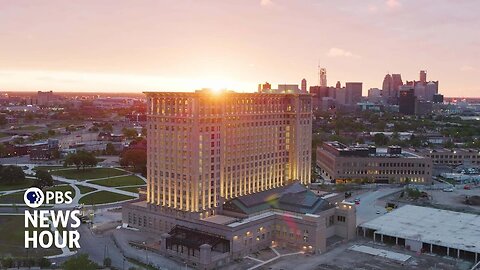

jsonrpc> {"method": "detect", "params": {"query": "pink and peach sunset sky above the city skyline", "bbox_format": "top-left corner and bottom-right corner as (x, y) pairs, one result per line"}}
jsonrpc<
(0, 0), (480, 96)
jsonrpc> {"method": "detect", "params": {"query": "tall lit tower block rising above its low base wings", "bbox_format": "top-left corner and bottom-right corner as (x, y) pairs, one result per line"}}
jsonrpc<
(141, 90), (312, 214)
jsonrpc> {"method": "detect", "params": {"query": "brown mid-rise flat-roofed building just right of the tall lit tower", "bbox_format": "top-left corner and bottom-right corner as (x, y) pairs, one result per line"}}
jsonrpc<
(317, 142), (432, 184)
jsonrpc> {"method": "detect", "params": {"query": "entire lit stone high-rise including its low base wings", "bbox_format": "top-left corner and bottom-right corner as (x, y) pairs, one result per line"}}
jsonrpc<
(123, 90), (355, 269)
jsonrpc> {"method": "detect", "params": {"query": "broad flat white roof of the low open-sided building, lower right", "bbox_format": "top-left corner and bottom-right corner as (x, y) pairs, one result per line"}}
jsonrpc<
(360, 205), (480, 253)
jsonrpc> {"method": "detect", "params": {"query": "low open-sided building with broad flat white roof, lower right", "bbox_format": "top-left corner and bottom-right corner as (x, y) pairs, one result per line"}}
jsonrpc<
(357, 205), (480, 262)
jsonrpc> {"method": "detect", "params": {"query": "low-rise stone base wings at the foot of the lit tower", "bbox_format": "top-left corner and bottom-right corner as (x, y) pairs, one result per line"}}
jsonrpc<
(123, 182), (356, 269)
